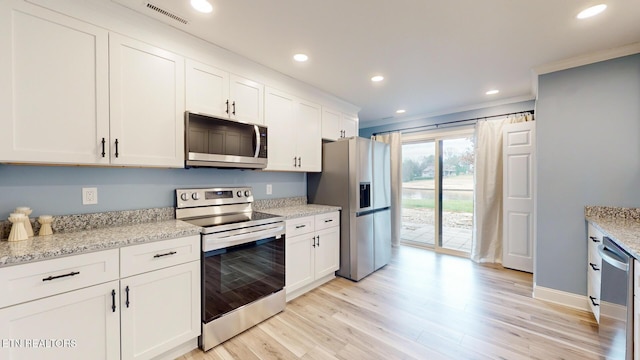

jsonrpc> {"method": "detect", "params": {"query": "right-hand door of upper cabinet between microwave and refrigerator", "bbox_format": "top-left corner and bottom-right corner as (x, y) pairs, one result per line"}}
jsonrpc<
(293, 100), (322, 172)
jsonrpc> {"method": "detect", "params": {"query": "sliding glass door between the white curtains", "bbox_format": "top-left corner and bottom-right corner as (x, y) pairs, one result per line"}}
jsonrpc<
(401, 129), (475, 256)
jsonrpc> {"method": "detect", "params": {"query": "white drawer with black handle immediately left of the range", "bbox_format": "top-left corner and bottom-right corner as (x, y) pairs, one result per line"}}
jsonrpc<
(120, 235), (200, 278)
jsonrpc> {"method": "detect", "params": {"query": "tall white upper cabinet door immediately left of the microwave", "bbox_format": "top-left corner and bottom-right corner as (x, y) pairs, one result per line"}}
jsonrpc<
(109, 34), (184, 167)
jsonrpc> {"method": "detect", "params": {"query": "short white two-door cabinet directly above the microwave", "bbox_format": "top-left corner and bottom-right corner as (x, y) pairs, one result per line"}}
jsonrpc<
(186, 60), (264, 124)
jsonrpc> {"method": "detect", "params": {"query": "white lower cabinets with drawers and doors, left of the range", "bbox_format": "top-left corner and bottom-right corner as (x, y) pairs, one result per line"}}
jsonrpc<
(0, 235), (200, 360)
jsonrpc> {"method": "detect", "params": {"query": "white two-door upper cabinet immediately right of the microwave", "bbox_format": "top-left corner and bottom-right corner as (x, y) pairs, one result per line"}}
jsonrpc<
(265, 88), (322, 172)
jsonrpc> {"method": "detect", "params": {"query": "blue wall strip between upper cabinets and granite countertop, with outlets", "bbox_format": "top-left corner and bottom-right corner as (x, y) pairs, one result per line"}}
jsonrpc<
(0, 164), (307, 220)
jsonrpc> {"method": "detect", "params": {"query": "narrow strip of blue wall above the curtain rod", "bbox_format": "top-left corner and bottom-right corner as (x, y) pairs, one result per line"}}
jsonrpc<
(360, 100), (535, 137)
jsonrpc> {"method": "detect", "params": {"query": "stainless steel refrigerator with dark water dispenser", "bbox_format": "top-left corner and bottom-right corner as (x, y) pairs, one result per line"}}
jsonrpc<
(307, 137), (391, 281)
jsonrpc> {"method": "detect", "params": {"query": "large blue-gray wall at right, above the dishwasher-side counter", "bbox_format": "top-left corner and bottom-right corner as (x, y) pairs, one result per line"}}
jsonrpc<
(535, 55), (640, 295)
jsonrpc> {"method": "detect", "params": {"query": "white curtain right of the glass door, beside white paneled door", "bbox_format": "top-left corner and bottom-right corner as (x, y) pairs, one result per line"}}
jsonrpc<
(471, 114), (533, 263)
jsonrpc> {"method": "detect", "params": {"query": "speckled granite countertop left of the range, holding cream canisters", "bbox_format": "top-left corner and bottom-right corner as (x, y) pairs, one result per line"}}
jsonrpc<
(0, 220), (201, 267)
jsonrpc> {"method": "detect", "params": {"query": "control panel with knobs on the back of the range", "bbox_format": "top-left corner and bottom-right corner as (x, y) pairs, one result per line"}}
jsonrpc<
(176, 187), (253, 209)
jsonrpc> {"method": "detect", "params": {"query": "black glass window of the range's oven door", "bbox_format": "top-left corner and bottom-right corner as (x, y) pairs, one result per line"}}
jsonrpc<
(202, 234), (285, 323)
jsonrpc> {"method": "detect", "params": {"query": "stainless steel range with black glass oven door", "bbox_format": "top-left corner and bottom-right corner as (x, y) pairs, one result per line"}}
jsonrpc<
(176, 187), (286, 351)
